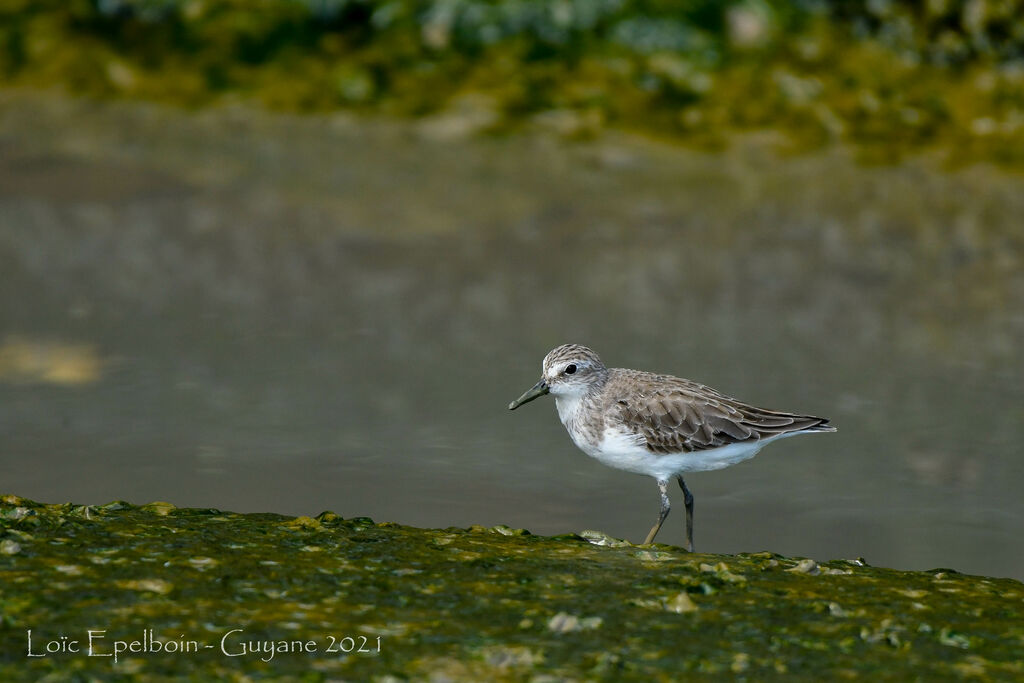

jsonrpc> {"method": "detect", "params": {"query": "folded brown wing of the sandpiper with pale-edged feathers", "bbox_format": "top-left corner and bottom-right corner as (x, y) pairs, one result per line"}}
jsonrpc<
(606, 369), (834, 453)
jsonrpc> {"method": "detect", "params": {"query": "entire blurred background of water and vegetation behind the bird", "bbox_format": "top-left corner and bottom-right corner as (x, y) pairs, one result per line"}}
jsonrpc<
(0, 0), (1024, 579)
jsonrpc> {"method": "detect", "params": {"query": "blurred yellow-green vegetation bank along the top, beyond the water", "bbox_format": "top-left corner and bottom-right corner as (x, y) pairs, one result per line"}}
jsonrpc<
(0, 0), (1024, 165)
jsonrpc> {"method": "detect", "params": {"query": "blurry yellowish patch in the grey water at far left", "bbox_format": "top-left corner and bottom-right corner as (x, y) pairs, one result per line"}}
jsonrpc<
(0, 337), (102, 385)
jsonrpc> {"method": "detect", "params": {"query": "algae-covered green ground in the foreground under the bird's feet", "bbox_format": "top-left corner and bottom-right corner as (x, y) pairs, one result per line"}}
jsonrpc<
(0, 496), (1024, 681)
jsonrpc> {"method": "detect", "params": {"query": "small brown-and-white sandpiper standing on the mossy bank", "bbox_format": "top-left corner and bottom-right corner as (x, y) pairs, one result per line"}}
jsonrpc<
(509, 344), (836, 552)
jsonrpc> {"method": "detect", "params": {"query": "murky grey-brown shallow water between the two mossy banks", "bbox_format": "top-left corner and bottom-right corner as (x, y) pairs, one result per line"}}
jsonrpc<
(0, 92), (1024, 578)
